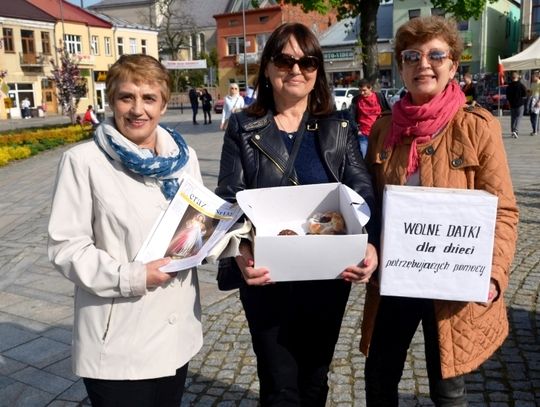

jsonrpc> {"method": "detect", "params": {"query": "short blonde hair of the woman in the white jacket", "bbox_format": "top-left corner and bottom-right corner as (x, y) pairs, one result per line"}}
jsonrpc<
(106, 54), (171, 104)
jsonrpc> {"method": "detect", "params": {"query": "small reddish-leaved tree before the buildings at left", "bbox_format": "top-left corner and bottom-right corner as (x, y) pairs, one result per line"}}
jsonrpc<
(49, 47), (88, 124)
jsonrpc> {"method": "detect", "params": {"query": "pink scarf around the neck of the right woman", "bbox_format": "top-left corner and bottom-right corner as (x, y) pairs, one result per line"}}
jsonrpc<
(385, 80), (465, 177)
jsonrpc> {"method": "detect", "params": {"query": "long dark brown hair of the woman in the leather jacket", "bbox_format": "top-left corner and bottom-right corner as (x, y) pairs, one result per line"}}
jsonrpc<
(246, 23), (334, 116)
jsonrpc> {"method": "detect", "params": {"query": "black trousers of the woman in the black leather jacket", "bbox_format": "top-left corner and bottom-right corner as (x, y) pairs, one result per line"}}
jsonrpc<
(240, 280), (351, 407)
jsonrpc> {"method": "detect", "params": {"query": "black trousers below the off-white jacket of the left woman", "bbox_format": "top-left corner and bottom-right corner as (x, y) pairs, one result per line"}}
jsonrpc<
(83, 363), (188, 407)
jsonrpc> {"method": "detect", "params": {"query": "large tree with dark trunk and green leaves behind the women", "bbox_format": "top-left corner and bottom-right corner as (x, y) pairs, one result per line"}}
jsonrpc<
(284, 0), (497, 83)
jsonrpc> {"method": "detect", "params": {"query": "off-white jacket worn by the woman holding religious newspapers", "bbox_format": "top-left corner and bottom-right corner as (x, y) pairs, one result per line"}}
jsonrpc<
(49, 141), (202, 380)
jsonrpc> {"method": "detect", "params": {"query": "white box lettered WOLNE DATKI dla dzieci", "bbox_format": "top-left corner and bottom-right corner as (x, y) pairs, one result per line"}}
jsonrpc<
(379, 185), (498, 302)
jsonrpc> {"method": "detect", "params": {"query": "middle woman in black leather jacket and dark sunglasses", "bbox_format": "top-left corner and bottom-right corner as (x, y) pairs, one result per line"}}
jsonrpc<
(216, 23), (378, 407)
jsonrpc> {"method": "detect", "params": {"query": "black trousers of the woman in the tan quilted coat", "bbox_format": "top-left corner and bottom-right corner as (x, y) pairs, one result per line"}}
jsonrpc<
(365, 297), (468, 407)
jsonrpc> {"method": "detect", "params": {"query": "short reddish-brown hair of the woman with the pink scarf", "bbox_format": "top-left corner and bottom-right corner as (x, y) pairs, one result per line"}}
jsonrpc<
(394, 16), (463, 69)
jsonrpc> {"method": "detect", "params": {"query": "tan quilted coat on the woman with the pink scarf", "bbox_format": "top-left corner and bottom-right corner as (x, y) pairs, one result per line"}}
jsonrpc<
(360, 108), (518, 378)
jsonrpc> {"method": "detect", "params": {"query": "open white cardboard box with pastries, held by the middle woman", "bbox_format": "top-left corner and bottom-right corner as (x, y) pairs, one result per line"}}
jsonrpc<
(236, 183), (370, 281)
